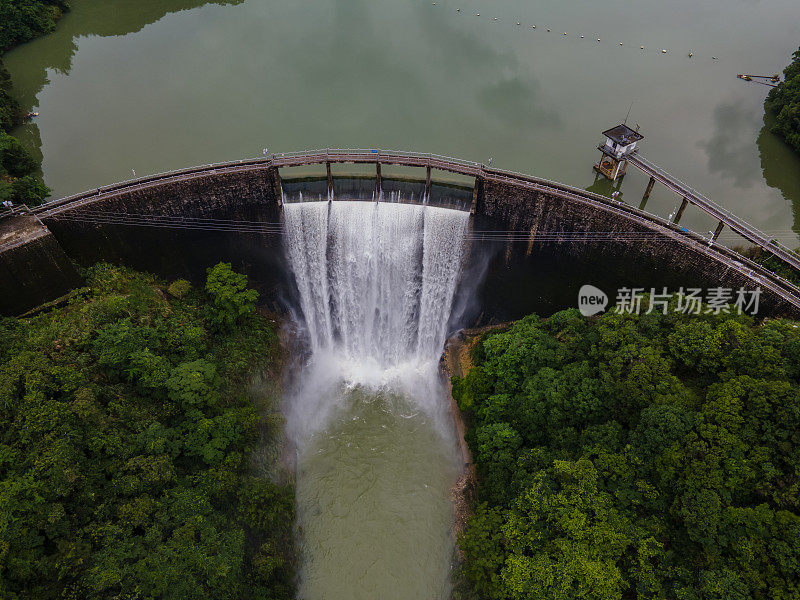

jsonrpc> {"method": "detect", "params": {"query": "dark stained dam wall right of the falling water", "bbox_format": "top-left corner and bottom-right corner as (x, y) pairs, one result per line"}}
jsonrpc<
(474, 178), (800, 318)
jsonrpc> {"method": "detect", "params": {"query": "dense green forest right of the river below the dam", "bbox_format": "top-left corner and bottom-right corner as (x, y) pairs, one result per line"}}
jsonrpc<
(453, 310), (800, 600)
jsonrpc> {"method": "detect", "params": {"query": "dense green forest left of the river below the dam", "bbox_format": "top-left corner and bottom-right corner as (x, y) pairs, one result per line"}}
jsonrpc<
(0, 263), (296, 600)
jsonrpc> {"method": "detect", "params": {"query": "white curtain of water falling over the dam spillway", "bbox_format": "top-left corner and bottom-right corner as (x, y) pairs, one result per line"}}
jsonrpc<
(284, 201), (469, 369)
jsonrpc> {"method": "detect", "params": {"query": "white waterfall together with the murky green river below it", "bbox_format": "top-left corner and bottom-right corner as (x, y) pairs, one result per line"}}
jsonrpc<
(283, 201), (469, 600)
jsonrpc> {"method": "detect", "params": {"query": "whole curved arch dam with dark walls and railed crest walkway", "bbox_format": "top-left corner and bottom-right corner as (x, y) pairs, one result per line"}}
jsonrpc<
(0, 149), (800, 322)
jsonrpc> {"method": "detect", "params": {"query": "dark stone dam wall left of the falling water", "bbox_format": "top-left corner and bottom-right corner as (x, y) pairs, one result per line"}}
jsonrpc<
(40, 169), (283, 288)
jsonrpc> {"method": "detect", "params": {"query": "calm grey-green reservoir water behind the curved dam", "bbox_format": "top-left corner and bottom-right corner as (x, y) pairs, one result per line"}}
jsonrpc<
(6, 0), (800, 247)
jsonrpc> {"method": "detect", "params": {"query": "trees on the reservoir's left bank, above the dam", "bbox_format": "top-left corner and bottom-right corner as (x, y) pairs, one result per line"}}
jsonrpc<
(0, 0), (69, 204)
